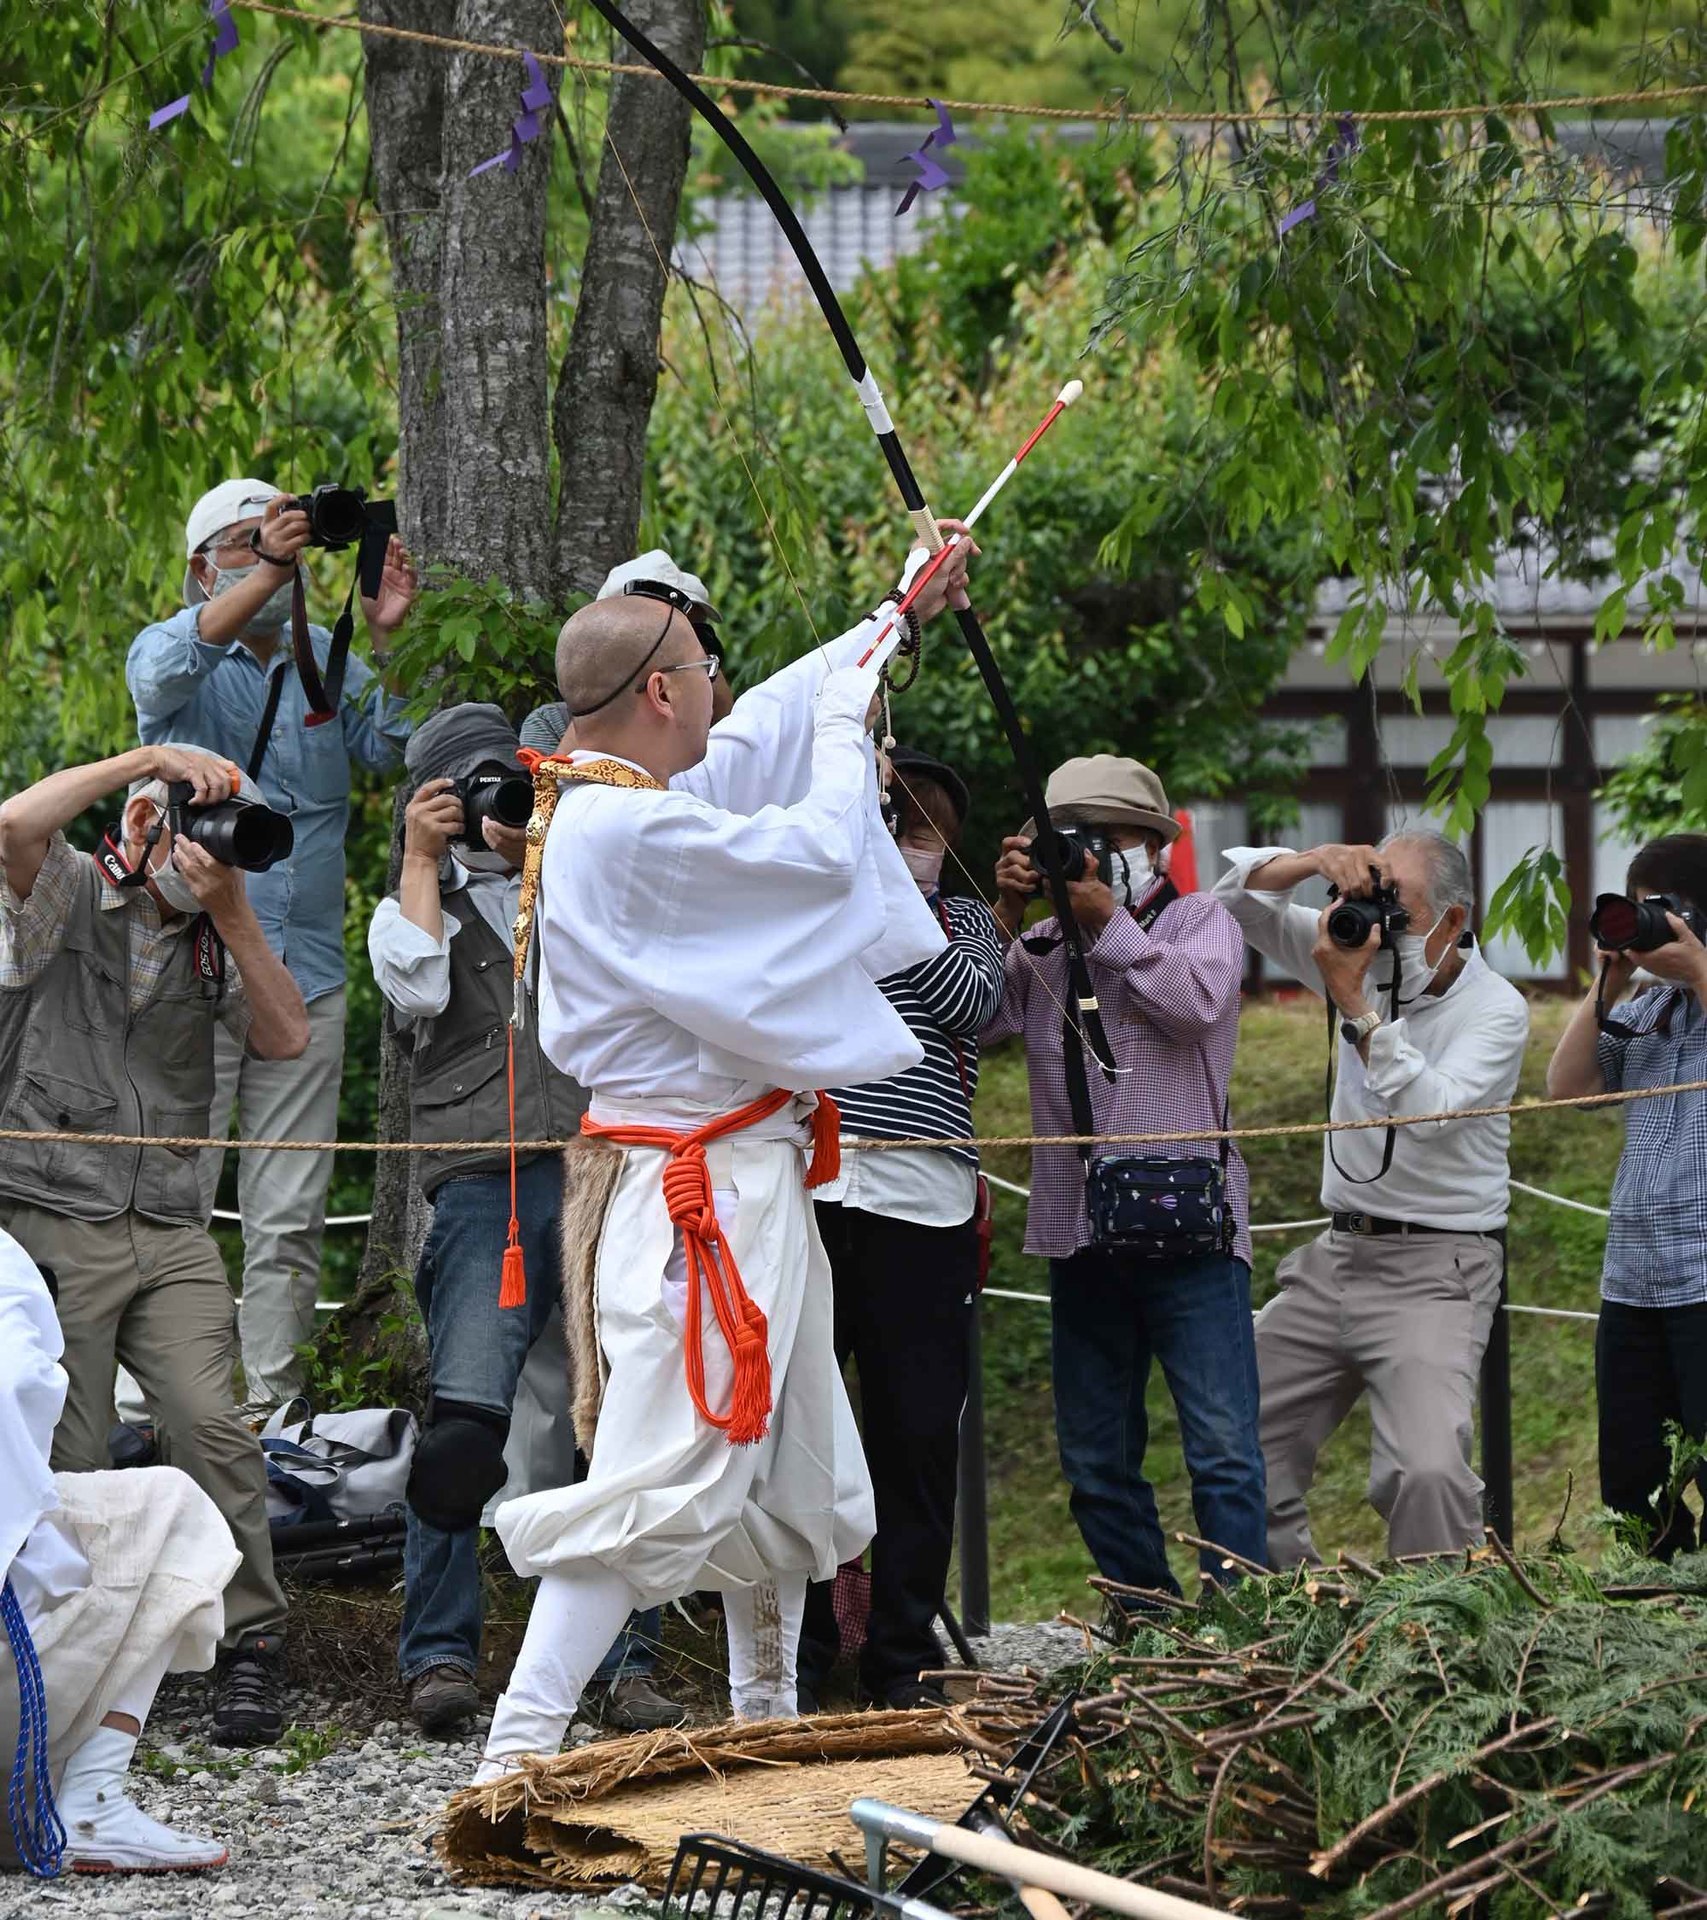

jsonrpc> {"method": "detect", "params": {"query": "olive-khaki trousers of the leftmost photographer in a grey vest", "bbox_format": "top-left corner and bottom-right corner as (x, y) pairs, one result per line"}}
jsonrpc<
(0, 1202), (284, 1647)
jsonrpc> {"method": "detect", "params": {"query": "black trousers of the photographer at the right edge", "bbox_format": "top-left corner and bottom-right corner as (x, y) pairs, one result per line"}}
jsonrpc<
(1594, 1300), (1707, 1559)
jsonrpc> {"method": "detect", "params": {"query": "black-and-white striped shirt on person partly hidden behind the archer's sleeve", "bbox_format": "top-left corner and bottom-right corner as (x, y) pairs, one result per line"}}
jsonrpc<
(831, 895), (1004, 1167)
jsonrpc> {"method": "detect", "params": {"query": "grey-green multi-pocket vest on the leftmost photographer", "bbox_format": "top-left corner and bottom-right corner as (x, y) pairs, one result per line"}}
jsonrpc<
(0, 858), (225, 1227)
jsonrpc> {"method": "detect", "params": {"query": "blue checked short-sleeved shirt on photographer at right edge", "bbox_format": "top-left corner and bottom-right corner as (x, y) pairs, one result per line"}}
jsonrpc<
(1599, 987), (1707, 1308)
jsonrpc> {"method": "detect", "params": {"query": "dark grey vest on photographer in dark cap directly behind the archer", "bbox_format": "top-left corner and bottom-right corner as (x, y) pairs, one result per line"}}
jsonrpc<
(409, 897), (588, 1194)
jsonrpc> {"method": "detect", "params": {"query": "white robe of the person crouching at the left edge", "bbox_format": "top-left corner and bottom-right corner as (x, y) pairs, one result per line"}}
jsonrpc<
(0, 1233), (240, 1835)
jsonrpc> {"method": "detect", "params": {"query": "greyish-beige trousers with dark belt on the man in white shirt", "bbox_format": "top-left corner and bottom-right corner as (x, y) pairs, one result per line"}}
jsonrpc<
(1256, 1229), (1503, 1569)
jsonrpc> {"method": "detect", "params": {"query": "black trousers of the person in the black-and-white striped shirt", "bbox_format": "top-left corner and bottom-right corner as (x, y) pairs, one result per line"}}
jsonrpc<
(799, 1204), (977, 1701)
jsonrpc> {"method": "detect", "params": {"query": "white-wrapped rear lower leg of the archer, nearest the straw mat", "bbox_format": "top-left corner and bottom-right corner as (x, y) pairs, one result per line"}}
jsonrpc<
(474, 1561), (639, 1788)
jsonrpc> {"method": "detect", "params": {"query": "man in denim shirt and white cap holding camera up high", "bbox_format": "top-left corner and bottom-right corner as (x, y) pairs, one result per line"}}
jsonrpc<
(125, 480), (417, 1407)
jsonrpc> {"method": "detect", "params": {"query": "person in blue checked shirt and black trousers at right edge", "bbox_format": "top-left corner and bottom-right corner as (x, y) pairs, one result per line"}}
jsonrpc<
(1548, 833), (1707, 1559)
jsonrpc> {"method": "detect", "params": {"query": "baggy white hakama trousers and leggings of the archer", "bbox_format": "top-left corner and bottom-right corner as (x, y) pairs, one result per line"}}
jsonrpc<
(486, 1135), (876, 1770)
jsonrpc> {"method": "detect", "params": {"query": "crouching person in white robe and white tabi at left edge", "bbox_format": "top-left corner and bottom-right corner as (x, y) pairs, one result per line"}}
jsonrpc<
(0, 1233), (240, 1872)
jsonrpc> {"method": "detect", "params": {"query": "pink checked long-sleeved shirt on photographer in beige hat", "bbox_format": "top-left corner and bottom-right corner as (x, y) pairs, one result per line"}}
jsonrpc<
(981, 893), (1250, 1263)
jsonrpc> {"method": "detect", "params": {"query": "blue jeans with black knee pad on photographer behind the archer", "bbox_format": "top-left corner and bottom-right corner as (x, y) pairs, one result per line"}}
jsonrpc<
(397, 1156), (661, 1682)
